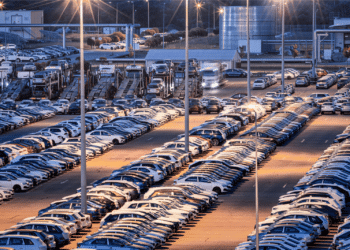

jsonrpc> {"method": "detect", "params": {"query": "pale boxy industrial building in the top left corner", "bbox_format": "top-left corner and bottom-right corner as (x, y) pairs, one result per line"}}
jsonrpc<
(0, 10), (44, 39)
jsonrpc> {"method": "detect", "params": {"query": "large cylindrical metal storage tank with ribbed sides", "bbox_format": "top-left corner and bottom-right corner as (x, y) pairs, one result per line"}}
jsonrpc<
(220, 6), (277, 49)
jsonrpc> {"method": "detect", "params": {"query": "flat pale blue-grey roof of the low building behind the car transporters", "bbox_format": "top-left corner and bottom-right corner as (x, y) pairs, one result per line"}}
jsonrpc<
(145, 49), (238, 61)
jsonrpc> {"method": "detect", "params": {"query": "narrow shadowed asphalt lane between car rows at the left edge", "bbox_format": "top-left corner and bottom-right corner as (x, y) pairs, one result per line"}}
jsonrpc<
(0, 115), (76, 143)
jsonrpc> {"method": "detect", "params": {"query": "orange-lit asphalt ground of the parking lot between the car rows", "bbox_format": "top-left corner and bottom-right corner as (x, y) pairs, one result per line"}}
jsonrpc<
(0, 73), (349, 249)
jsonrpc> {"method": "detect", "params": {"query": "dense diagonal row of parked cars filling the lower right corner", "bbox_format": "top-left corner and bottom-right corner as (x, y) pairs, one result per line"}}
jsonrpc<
(236, 122), (350, 250)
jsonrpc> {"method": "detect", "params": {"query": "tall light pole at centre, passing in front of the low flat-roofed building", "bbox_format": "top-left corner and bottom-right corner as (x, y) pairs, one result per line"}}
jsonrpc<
(185, 0), (190, 152)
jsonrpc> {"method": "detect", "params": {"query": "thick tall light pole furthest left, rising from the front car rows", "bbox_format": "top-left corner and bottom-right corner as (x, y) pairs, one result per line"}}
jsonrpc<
(80, 0), (87, 213)
